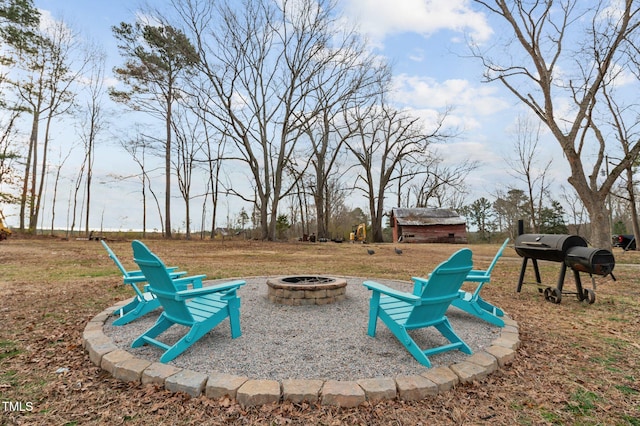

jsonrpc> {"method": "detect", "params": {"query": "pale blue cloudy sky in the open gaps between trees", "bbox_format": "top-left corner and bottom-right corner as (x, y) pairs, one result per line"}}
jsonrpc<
(10, 0), (566, 230)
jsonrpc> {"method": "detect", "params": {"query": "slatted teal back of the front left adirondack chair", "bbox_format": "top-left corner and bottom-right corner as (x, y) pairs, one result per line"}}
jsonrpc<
(131, 241), (193, 323)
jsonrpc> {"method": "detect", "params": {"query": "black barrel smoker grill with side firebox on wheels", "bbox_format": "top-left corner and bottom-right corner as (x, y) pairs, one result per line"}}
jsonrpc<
(515, 234), (616, 304)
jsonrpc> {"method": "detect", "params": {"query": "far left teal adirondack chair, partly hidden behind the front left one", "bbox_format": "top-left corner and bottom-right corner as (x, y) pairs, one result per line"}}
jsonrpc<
(100, 240), (190, 325)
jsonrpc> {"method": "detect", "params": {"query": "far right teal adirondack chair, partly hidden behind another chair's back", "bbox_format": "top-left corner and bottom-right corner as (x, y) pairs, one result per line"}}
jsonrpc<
(451, 238), (509, 327)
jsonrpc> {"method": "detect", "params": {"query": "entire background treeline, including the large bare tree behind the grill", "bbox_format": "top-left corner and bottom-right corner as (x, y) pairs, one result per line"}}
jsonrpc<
(0, 0), (640, 247)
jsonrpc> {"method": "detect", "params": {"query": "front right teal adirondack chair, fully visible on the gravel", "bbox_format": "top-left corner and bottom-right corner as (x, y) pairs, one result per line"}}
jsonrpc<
(363, 249), (473, 367)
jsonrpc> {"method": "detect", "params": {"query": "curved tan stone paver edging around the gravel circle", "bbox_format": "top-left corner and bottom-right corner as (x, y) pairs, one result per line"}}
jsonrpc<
(82, 300), (520, 407)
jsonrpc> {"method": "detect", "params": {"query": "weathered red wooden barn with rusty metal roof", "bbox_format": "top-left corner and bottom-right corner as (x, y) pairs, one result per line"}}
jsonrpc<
(391, 208), (467, 244)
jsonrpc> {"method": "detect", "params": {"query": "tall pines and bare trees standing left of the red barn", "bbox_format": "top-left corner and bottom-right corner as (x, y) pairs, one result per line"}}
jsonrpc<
(0, 0), (476, 241)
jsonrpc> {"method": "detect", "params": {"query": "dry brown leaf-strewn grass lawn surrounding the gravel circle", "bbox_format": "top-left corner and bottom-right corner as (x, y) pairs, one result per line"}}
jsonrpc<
(0, 236), (640, 425)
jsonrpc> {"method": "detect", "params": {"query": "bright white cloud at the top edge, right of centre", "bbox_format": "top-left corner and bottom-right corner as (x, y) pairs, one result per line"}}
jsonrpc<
(344, 0), (492, 43)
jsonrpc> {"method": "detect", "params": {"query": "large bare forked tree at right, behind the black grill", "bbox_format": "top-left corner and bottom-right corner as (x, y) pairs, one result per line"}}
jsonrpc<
(474, 0), (640, 247)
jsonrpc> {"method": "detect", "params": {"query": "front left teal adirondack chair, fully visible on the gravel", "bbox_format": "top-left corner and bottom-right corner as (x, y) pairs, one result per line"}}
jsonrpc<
(131, 241), (246, 363)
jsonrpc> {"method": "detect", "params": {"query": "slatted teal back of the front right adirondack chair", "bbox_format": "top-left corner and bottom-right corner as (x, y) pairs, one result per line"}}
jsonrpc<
(406, 248), (473, 327)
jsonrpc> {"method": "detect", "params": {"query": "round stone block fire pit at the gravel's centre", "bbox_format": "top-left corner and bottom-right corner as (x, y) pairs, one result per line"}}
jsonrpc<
(267, 275), (347, 306)
